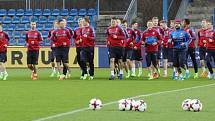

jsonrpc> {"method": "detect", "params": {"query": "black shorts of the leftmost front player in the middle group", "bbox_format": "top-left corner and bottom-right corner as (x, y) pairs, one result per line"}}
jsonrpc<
(110, 47), (124, 59)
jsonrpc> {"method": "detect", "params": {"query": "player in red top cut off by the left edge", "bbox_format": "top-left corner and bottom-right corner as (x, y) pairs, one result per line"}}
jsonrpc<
(0, 23), (9, 80)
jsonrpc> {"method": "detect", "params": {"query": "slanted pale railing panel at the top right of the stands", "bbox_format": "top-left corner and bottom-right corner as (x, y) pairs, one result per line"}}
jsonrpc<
(176, 0), (189, 19)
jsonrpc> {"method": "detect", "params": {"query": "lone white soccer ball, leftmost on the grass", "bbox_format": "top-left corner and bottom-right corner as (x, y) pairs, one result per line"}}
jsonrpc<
(89, 98), (102, 110)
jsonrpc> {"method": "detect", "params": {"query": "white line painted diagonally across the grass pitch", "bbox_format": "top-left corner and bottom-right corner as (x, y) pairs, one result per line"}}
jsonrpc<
(33, 83), (215, 121)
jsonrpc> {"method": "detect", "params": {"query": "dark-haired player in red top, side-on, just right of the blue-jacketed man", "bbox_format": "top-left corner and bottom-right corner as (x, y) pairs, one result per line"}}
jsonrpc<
(183, 19), (198, 79)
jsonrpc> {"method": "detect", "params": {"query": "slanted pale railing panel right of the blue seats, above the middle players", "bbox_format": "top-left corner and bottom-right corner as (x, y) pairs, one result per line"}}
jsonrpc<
(124, 0), (137, 24)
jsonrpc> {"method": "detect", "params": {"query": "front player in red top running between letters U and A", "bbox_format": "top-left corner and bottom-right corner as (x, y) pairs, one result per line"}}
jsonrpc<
(51, 19), (71, 80)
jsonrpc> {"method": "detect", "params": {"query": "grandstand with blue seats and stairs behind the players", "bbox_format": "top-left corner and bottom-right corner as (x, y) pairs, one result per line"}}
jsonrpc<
(0, 0), (215, 46)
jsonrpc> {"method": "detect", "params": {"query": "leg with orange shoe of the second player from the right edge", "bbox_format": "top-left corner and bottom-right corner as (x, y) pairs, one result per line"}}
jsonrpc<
(199, 48), (208, 77)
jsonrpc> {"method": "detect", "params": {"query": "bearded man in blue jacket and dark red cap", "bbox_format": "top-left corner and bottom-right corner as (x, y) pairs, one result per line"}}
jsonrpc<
(169, 20), (190, 80)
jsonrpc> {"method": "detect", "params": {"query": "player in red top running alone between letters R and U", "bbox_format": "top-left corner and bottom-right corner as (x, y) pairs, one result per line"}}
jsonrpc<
(25, 22), (43, 80)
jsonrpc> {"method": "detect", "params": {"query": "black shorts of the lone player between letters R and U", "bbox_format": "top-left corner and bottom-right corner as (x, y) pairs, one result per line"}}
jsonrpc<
(27, 50), (39, 65)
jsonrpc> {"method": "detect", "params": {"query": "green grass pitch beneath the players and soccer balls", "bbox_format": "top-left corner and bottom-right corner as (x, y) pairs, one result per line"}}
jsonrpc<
(0, 68), (215, 121)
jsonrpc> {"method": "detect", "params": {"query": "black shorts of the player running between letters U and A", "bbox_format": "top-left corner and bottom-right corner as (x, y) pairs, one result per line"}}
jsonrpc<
(55, 47), (70, 63)
